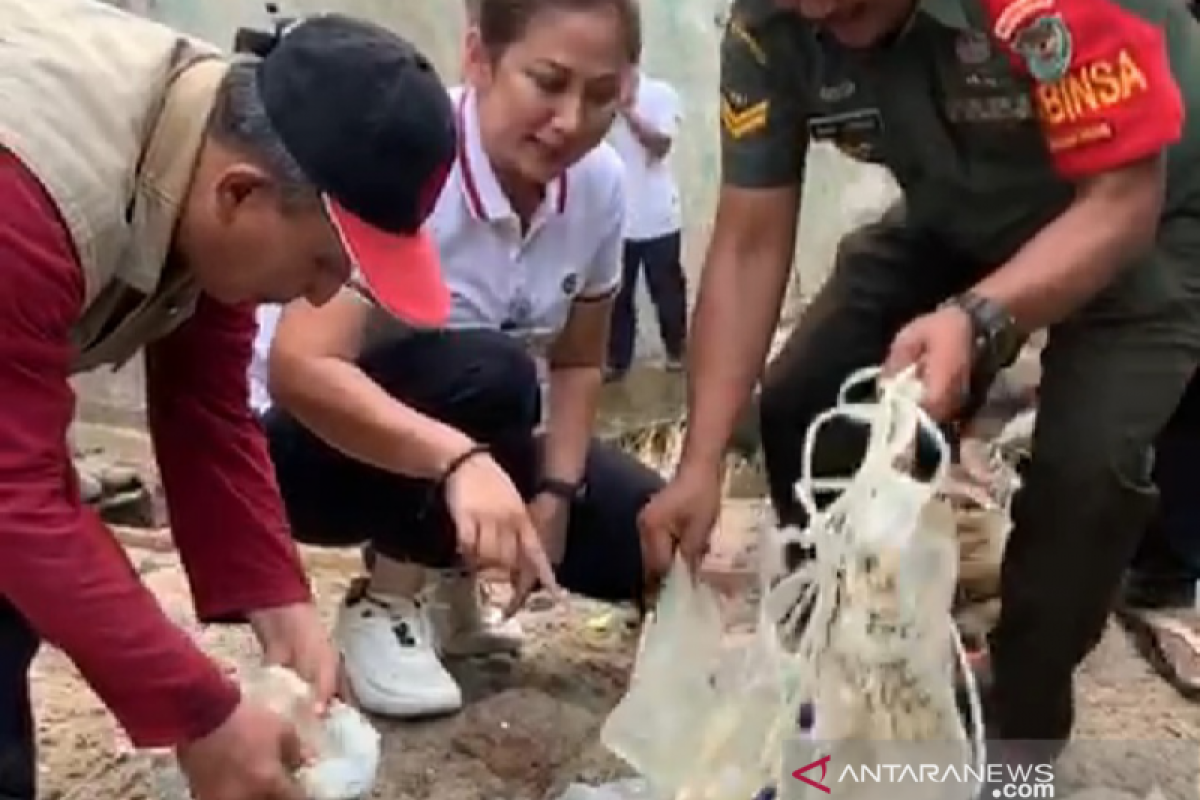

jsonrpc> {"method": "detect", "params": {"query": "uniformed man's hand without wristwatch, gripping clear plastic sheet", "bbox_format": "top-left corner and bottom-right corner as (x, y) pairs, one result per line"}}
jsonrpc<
(637, 465), (721, 583)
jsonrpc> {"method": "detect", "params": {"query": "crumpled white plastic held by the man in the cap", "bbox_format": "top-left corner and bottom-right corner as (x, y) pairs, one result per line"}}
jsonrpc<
(151, 667), (380, 800)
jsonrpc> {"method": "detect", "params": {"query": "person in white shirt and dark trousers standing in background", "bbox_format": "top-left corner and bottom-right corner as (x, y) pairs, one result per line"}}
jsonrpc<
(607, 64), (688, 380)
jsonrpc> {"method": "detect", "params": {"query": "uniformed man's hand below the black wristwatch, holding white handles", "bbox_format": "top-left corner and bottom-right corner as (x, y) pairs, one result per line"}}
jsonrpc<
(883, 305), (973, 422)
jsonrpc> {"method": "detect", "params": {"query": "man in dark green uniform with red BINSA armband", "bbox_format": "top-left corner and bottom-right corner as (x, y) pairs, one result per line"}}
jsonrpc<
(643, 0), (1200, 754)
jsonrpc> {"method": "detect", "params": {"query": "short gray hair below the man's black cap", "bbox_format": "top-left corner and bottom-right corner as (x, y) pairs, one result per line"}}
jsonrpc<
(209, 61), (317, 201)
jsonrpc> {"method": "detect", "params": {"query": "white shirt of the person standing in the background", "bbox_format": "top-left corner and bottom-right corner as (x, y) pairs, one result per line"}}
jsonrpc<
(608, 73), (683, 240)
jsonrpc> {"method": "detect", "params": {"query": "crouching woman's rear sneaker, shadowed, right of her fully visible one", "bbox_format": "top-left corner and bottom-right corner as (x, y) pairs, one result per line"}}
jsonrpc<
(427, 570), (524, 657)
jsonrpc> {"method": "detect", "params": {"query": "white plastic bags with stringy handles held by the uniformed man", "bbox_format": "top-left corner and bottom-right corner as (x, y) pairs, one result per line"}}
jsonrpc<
(601, 368), (984, 800)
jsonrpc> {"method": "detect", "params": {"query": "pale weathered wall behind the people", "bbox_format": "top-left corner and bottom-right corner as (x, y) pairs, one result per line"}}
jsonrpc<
(79, 0), (894, 419)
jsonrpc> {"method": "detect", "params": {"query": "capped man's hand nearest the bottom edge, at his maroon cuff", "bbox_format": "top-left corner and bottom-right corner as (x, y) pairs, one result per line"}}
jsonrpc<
(178, 698), (310, 800)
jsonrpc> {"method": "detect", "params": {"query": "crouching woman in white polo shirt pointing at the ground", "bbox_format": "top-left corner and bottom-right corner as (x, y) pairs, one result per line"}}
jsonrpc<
(250, 0), (661, 716)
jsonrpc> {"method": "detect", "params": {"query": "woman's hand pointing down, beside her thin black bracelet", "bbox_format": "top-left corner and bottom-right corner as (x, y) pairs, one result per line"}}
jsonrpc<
(445, 452), (558, 591)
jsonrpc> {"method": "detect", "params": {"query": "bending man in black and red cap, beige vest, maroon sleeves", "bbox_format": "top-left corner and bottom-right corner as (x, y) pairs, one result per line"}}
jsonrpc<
(0, 0), (455, 800)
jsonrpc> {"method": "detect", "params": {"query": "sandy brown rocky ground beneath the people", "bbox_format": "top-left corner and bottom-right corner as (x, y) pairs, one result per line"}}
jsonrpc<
(34, 419), (1200, 800)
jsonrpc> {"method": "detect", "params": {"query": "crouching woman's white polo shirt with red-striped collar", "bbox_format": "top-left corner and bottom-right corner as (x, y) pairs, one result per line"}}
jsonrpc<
(250, 88), (625, 417)
